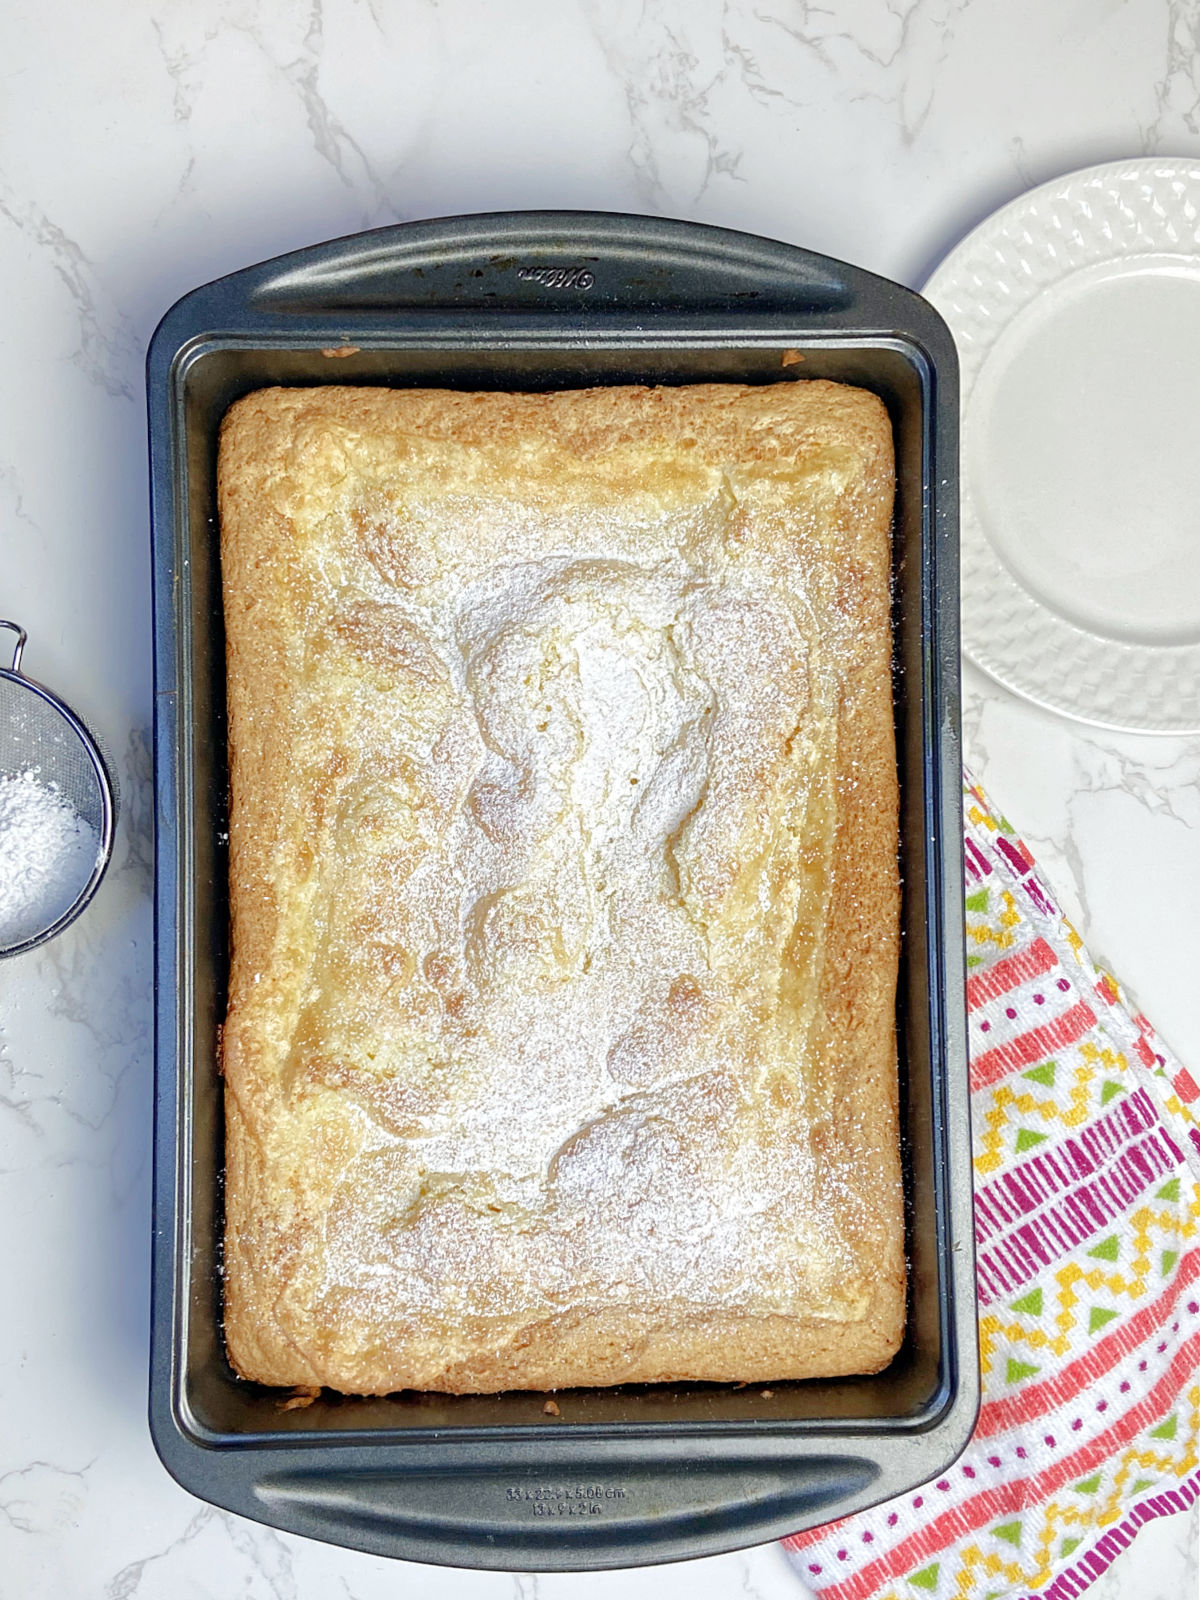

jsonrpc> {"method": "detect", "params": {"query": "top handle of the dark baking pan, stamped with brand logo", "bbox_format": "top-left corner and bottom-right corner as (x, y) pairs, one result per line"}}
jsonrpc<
(244, 211), (864, 324)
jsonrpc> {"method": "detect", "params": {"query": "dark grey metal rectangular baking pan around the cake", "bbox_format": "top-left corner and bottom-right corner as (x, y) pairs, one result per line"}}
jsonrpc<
(149, 213), (979, 1571)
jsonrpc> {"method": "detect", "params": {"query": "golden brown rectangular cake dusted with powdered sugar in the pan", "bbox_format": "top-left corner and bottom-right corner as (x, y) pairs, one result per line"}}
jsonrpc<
(219, 382), (906, 1394)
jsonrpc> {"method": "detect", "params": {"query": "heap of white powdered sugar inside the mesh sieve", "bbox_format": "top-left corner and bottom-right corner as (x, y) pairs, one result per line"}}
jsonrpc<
(0, 771), (99, 949)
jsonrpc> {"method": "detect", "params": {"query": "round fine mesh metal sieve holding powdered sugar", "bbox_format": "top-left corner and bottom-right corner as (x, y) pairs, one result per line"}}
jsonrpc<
(0, 619), (117, 957)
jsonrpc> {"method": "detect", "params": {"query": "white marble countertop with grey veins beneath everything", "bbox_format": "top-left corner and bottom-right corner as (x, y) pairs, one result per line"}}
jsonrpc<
(0, 0), (1200, 1600)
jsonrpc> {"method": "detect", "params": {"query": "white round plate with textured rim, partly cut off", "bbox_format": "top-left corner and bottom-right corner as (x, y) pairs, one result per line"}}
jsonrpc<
(923, 158), (1200, 733)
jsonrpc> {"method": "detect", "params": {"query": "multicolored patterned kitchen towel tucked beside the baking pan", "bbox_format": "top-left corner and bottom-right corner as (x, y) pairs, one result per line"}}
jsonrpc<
(784, 768), (1200, 1600)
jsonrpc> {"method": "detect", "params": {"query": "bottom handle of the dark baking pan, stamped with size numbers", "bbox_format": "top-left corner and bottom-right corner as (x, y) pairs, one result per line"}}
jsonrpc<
(256, 1456), (878, 1571)
